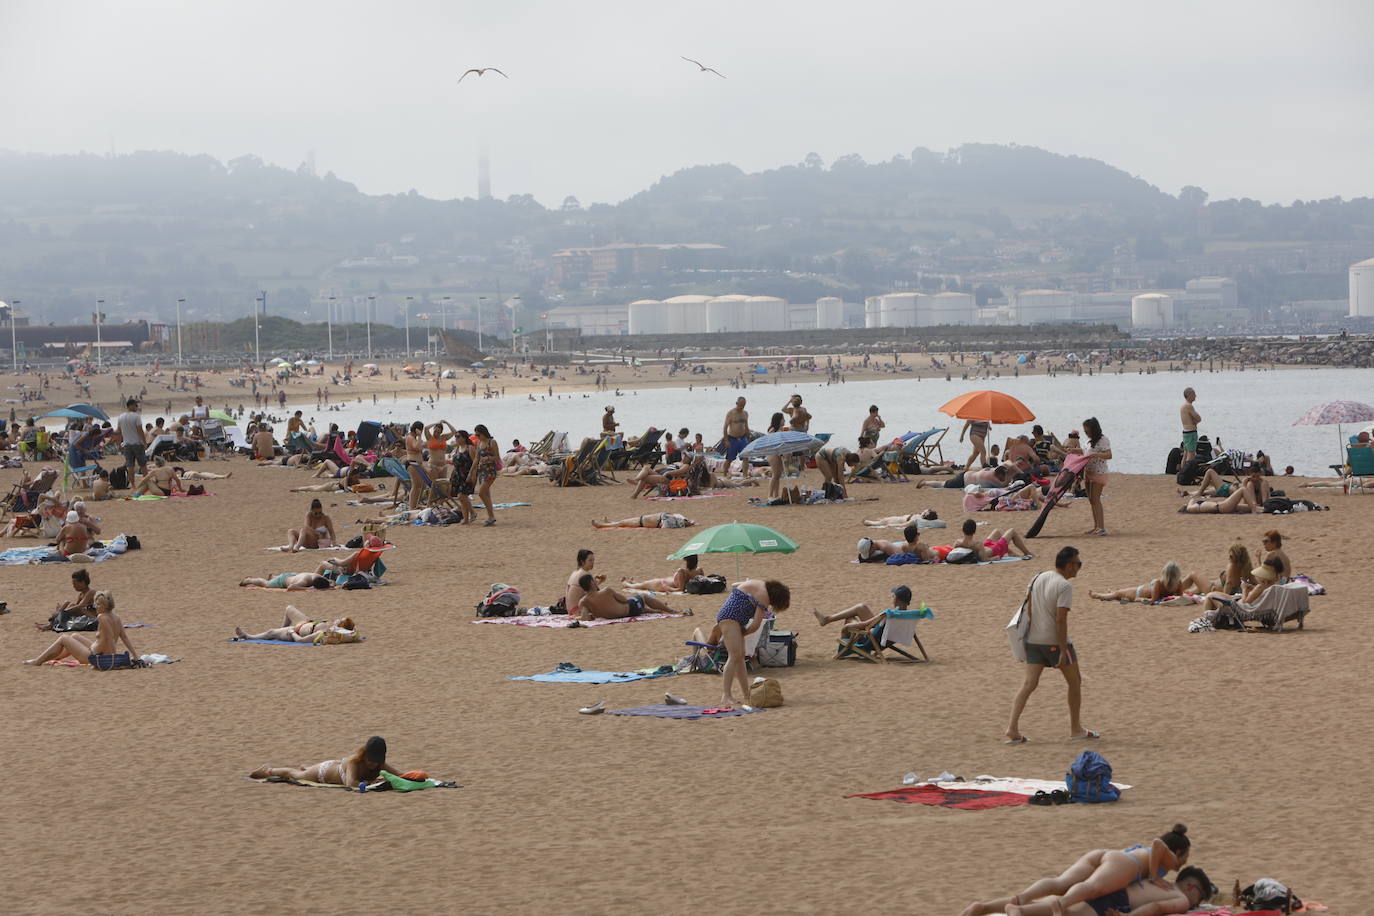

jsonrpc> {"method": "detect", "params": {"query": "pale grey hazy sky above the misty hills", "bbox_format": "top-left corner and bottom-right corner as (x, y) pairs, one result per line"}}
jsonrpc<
(0, 0), (1374, 206)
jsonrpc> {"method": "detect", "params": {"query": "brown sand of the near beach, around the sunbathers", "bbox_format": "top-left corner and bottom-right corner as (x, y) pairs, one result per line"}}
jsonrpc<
(0, 384), (1374, 915)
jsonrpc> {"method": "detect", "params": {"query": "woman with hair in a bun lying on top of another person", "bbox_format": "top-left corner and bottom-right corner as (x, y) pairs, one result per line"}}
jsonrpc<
(989, 824), (1191, 916)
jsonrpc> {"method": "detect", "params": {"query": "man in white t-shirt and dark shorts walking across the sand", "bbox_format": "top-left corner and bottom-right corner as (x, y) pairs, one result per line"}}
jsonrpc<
(1007, 547), (1101, 744)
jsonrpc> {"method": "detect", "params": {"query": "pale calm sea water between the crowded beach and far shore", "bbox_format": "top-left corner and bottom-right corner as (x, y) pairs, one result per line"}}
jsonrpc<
(289, 368), (1374, 477)
